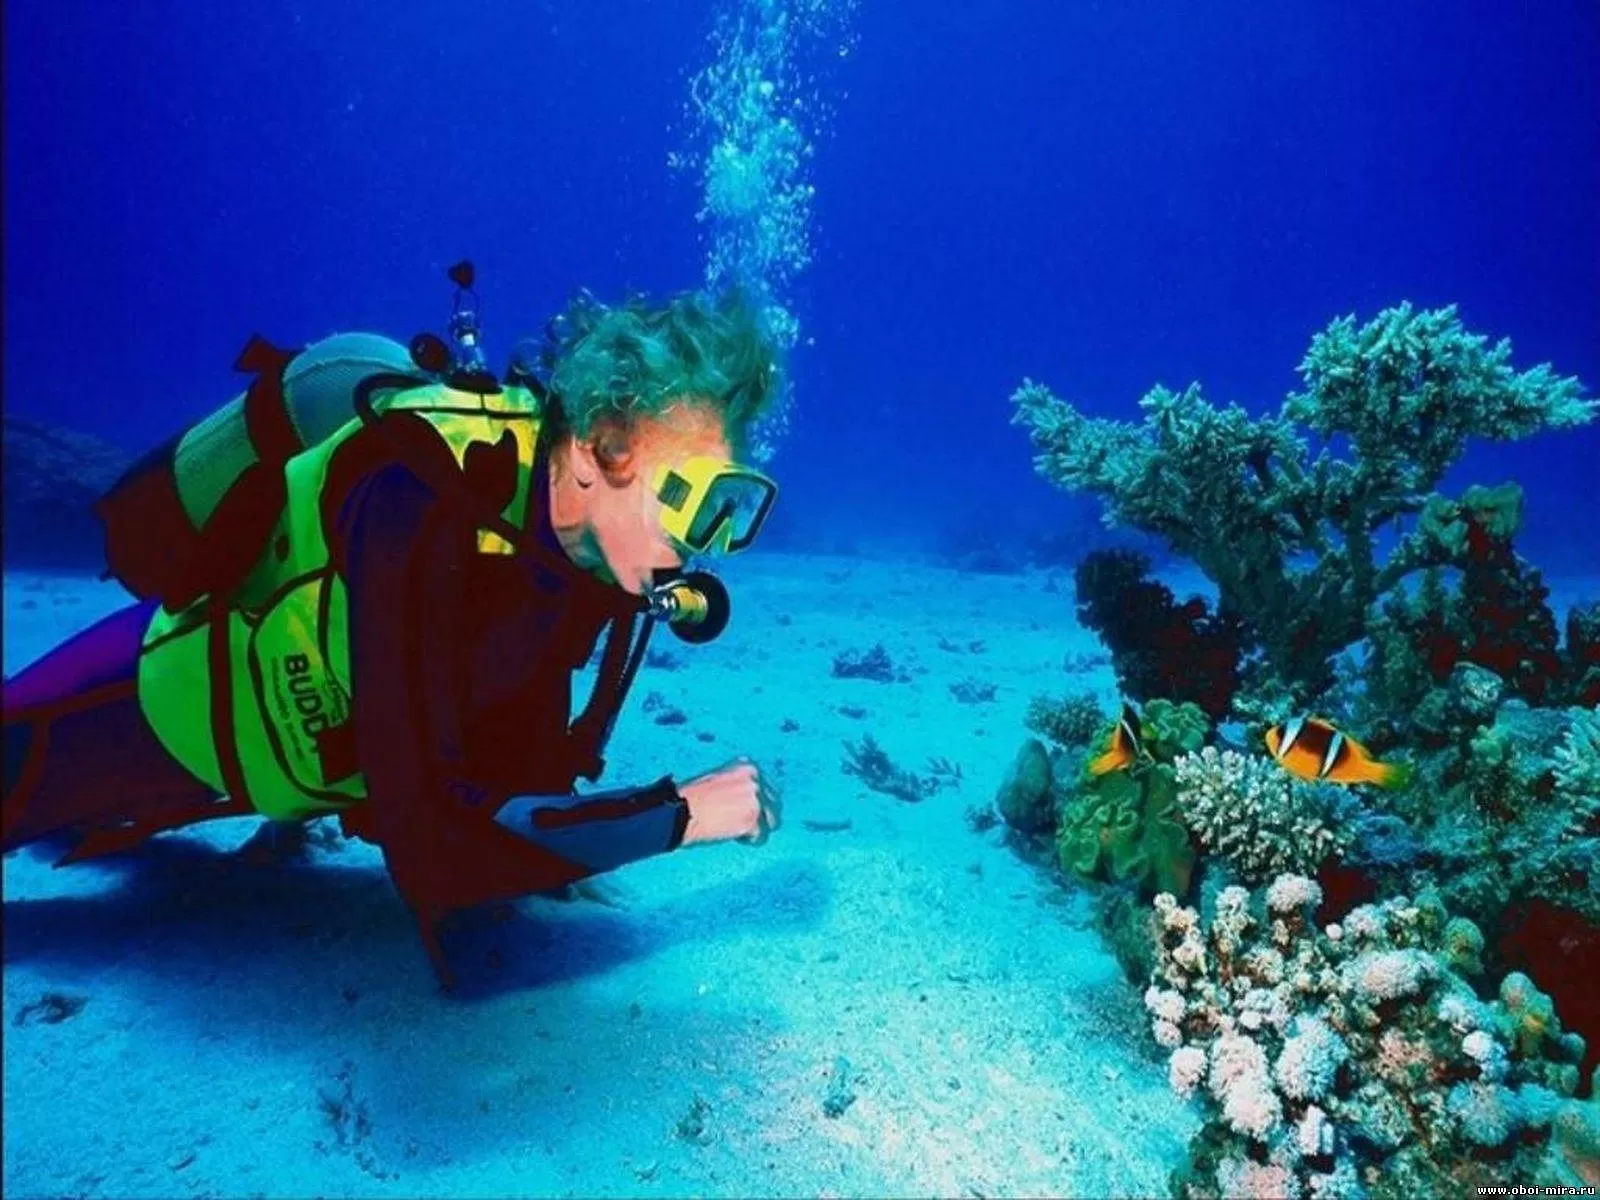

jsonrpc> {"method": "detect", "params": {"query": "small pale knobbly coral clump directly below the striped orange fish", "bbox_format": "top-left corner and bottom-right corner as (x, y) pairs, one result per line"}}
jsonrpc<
(1173, 746), (1350, 885)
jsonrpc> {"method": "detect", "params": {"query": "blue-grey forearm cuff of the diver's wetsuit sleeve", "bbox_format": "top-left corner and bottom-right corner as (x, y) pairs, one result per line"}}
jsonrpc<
(494, 776), (690, 874)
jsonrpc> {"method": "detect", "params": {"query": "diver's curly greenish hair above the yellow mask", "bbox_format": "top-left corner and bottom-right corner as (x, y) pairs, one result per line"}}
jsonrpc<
(539, 291), (782, 451)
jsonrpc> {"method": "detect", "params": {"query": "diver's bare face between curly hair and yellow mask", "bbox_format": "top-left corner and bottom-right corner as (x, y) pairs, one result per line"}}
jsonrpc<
(589, 405), (733, 595)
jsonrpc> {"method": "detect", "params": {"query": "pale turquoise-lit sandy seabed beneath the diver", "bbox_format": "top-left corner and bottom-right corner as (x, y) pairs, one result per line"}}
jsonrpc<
(5, 557), (1192, 1197)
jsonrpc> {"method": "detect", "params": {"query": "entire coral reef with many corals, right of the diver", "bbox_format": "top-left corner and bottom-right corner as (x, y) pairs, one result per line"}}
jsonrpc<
(992, 304), (1600, 1197)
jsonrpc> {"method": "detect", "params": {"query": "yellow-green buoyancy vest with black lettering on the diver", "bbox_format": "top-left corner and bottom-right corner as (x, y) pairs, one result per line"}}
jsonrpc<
(139, 376), (539, 821)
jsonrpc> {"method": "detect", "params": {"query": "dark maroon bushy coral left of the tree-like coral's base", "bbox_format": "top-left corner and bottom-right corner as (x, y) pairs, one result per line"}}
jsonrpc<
(1074, 550), (1240, 720)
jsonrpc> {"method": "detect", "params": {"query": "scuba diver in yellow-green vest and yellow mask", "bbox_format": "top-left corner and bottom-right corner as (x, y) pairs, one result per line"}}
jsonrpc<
(3, 262), (781, 987)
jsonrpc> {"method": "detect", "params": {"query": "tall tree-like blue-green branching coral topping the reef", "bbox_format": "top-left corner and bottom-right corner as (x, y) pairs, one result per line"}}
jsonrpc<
(1013, 304), (1597, 702)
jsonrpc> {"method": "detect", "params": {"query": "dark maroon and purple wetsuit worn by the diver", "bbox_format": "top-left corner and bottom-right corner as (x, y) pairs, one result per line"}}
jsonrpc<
(5, 438), (688, 978)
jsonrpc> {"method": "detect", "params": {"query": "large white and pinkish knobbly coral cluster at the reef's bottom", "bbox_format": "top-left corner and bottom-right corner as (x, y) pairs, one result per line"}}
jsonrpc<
(1146, 875), (1584, 1200)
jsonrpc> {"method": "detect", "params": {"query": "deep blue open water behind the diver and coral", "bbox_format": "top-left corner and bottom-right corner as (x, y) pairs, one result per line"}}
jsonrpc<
(5, 0), (1600, 570)
